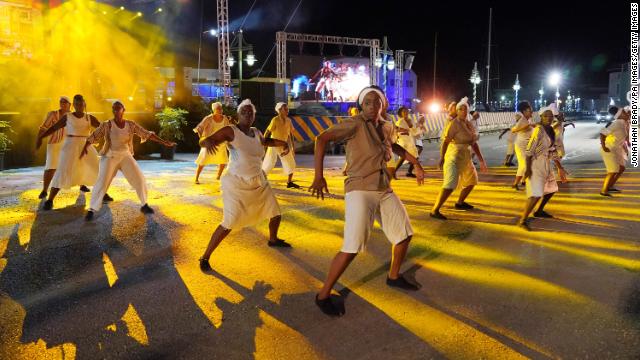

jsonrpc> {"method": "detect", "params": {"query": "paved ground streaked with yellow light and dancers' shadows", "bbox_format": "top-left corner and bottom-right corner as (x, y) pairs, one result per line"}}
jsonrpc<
(0, 123), (640, 359)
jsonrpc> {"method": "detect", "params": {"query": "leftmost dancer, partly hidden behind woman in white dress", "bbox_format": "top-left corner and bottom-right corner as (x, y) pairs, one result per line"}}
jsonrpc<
(36, 96), (71, 199)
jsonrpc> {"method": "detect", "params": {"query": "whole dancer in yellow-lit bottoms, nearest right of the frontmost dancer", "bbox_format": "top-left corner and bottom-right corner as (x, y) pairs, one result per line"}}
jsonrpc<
(429, 97), (487, 220)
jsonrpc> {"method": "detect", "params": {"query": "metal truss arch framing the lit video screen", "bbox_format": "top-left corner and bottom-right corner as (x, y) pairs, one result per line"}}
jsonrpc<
(276, 31), (380, 85)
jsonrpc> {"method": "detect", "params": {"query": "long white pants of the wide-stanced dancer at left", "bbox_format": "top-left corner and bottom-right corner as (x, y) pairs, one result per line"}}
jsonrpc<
(89, 153), (147, 211)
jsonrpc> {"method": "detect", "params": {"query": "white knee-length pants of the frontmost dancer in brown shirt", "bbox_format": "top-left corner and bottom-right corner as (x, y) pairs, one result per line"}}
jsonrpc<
(340, 190), (413, 254)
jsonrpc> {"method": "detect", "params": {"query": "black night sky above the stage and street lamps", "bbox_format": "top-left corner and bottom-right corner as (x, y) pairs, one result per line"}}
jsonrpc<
(122, 0), (629, 99)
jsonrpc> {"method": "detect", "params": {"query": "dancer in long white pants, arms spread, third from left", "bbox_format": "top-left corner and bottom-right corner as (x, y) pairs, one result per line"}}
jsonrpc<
(80, 100), (175, 221)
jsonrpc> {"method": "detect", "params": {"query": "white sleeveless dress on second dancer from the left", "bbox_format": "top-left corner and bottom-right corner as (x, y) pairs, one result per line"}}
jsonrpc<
(51, 112), (99, 189)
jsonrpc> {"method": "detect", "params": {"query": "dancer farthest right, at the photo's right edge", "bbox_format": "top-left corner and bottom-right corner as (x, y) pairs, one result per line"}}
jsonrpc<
(600, 107), (631, 196)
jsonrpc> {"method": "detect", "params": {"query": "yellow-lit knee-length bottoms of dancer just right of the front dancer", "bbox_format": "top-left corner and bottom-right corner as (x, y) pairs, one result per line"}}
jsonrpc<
(442, 144), (478, 190)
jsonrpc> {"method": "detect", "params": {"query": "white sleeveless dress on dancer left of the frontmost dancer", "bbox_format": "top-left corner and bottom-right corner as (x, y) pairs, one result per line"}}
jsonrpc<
(220, 125), (280, 230)
